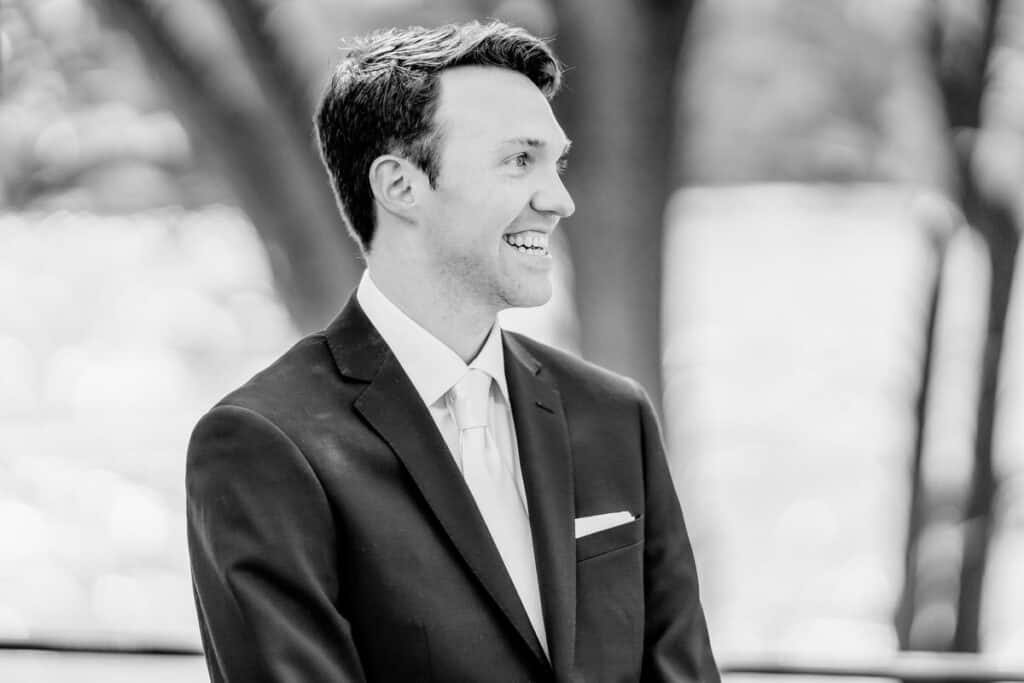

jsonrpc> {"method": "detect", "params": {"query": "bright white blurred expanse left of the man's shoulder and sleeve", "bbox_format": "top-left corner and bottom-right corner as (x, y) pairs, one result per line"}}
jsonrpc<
(0, 207), (295, 643)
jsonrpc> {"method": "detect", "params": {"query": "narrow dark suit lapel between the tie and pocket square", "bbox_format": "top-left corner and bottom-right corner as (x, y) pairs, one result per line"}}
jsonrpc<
(504, 334), (577, 680)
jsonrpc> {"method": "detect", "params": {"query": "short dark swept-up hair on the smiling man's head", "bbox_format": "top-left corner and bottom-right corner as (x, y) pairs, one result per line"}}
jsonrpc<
(314, 22), (562, 250)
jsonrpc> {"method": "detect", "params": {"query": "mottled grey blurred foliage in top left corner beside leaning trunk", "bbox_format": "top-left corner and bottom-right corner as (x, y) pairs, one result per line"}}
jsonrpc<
(0, 0), (223, 211)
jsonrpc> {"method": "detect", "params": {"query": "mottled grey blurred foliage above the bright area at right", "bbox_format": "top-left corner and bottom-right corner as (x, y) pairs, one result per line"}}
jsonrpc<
(679, 0), (951, 187)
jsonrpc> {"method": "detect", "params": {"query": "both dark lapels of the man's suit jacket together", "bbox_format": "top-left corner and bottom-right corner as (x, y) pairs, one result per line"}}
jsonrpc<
(325, 296), (575, 680)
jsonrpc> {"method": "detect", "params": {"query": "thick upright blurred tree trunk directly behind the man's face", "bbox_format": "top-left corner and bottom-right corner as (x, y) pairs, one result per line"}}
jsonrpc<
(553, 0), (691, 410)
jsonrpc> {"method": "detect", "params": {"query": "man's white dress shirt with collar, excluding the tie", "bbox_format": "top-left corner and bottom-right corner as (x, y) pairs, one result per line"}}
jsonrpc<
(355, 269), (548, 651)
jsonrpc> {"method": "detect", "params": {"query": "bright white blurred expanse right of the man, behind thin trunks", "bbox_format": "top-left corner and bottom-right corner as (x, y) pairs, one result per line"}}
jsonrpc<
(665, 183), (1024, 663)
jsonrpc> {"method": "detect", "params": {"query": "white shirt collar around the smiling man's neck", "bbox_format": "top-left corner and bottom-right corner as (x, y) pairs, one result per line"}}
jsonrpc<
(355, 268), (509, 405)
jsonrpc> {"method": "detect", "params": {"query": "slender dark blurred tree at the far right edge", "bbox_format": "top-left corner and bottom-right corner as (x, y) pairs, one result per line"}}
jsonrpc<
(897, 0), (1020, 652)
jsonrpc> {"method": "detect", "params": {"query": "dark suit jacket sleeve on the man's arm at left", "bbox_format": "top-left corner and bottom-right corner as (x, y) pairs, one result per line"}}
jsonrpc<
(185, 405), (365, 683)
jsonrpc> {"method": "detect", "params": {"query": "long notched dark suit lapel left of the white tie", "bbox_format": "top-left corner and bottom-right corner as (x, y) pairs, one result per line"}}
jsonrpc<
(327, 296), (547, 661)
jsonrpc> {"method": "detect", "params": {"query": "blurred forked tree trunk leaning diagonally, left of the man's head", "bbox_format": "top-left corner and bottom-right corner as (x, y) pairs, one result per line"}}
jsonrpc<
(94, 0), (360, 332)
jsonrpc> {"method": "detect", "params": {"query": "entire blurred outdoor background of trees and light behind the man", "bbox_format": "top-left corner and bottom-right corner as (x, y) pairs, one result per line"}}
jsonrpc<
(0, 0), (1024, 682)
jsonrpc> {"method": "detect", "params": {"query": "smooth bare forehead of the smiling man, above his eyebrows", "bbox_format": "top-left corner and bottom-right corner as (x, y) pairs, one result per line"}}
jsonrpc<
(435, 67), (566, 150)
